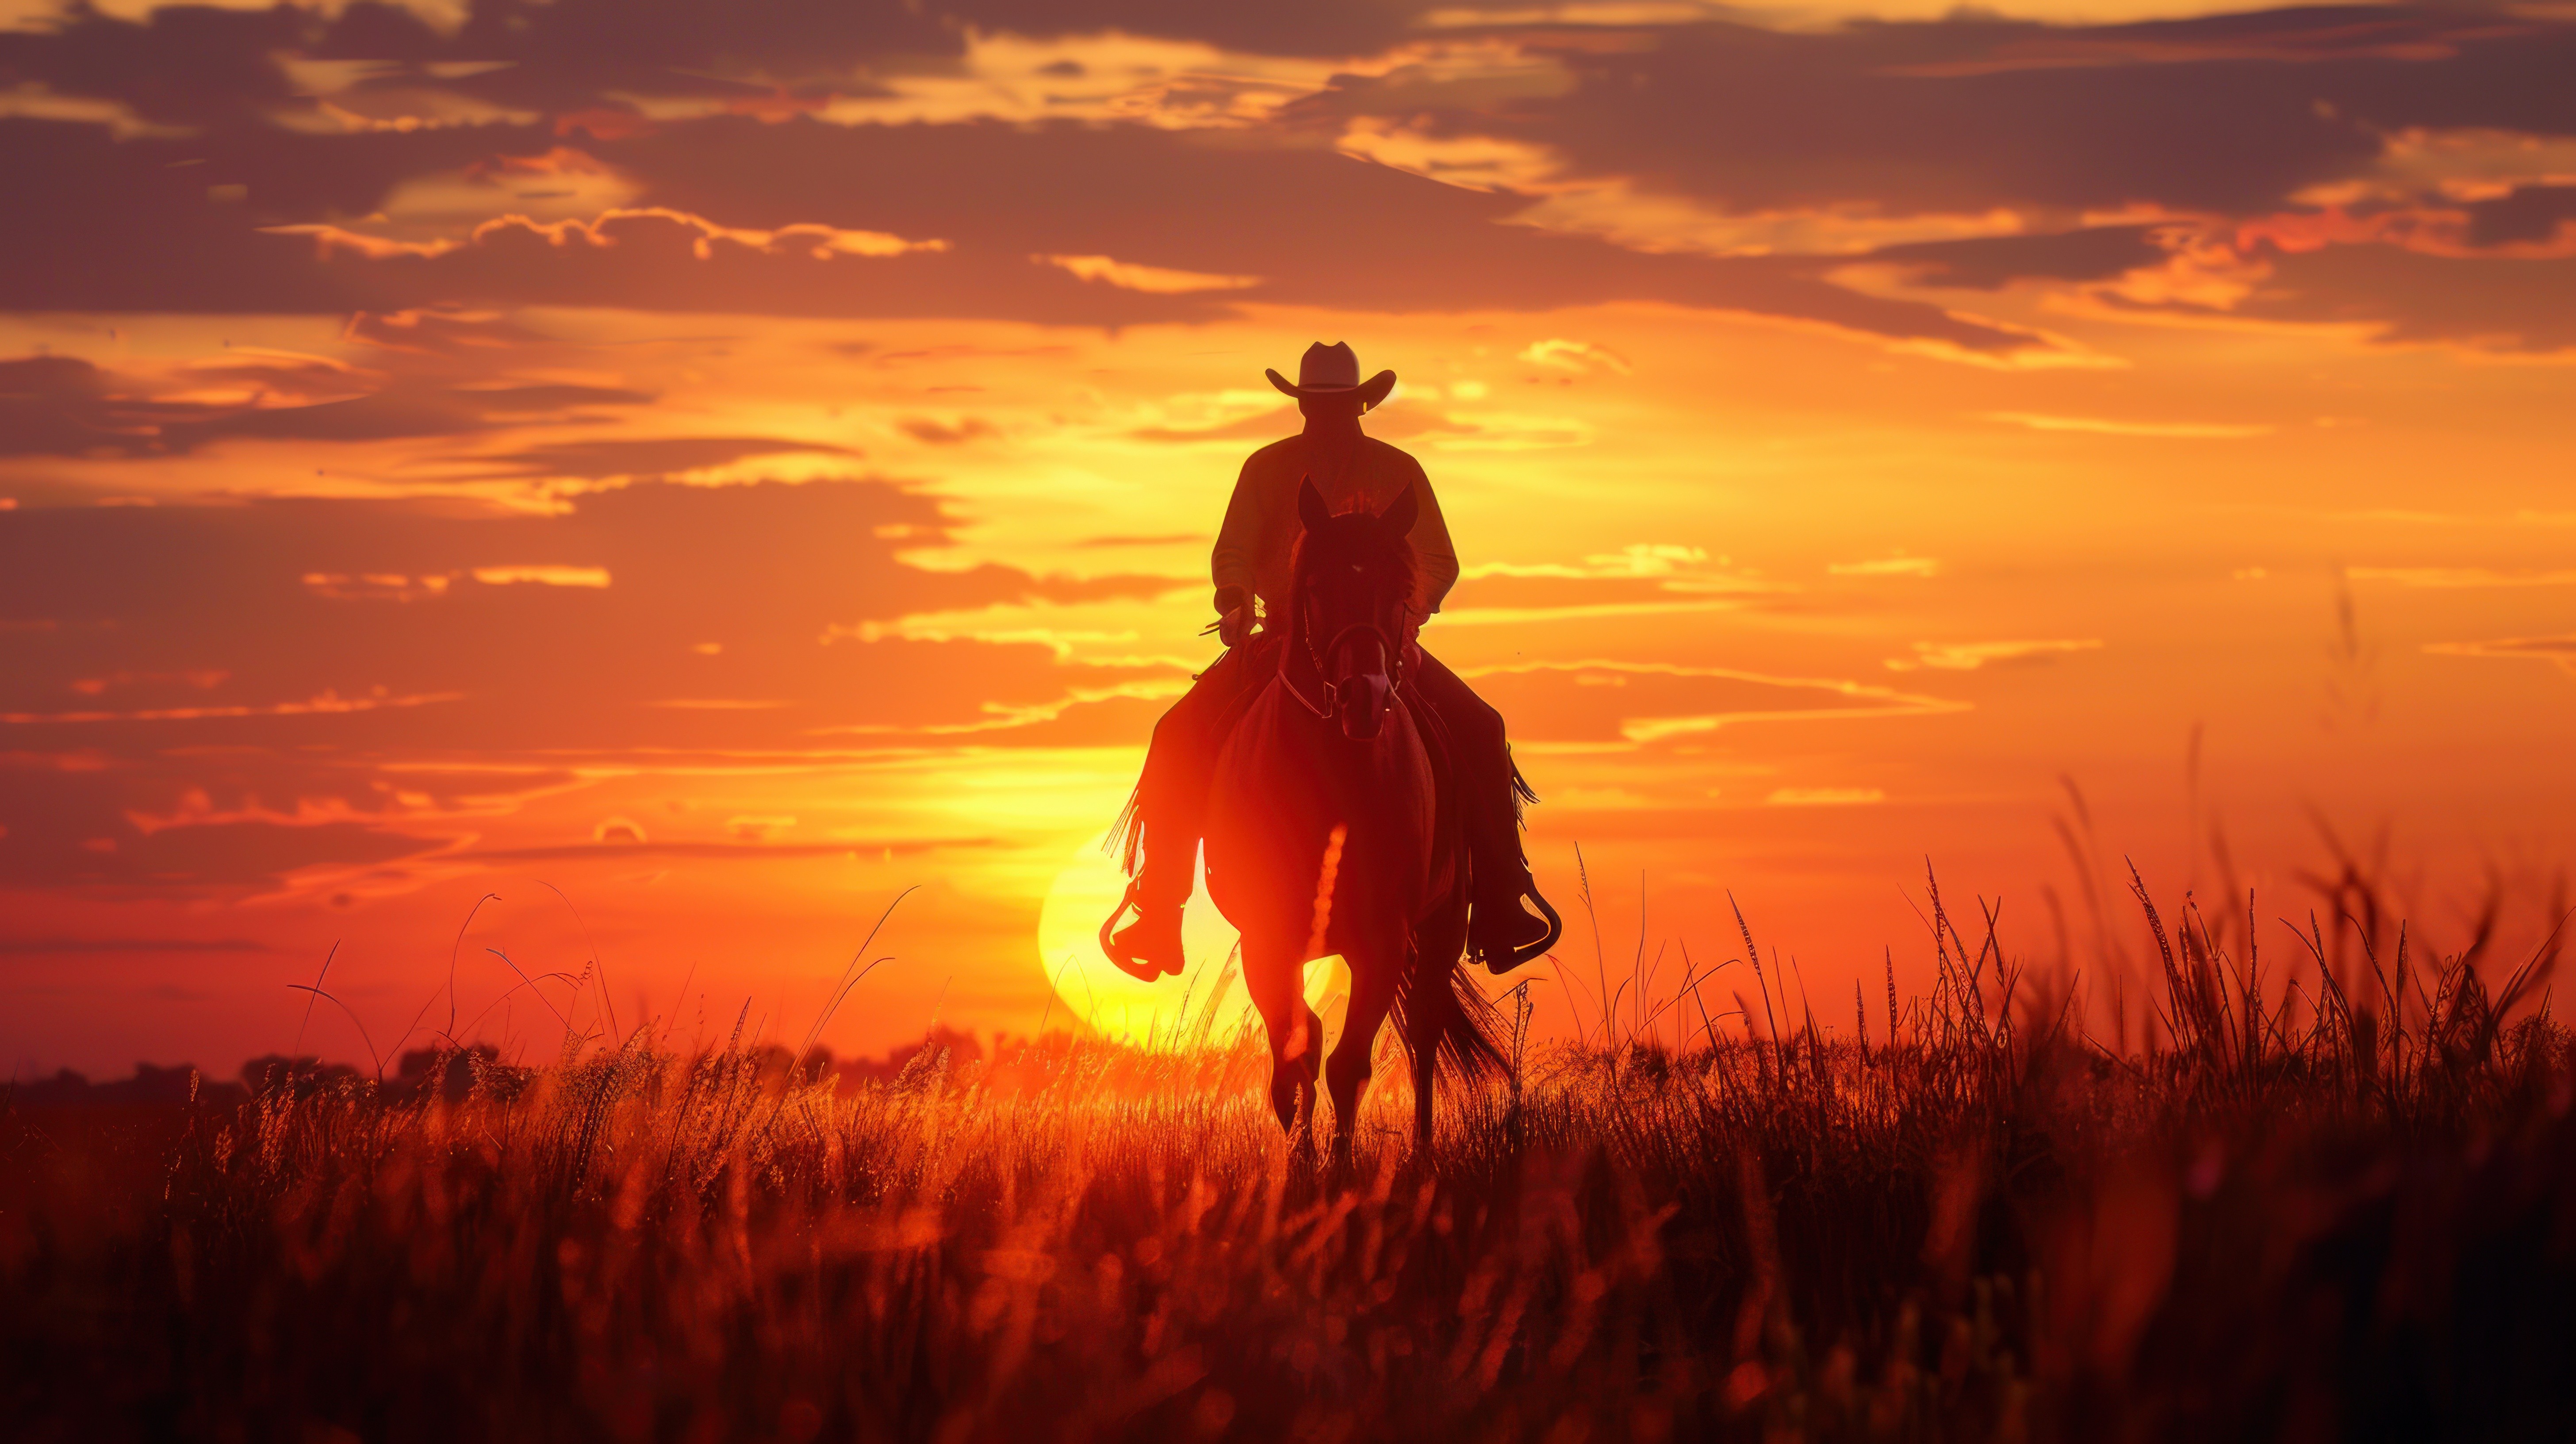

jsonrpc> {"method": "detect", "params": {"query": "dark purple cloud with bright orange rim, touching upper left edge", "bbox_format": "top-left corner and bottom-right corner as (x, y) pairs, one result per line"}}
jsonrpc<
(0, 121), (1208, 325)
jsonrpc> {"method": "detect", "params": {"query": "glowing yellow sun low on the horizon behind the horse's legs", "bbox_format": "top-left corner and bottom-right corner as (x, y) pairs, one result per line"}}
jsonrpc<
(1038, 838), (1347, 1047)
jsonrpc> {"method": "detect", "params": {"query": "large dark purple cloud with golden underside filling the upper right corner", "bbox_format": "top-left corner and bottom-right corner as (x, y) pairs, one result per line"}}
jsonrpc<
(1288, 8), (2576, 353)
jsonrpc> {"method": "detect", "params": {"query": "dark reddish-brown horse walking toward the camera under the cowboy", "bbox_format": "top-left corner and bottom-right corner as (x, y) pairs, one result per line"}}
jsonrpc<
(1206, 482), (1504, 1160)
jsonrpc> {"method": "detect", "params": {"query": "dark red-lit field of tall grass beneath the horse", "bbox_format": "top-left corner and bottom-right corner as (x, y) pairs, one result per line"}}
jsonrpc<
(0, 861), (2576, 1444)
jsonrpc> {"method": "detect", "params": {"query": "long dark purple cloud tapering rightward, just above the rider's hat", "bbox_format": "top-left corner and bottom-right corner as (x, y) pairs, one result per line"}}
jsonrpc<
(603, 119), (2038, 351)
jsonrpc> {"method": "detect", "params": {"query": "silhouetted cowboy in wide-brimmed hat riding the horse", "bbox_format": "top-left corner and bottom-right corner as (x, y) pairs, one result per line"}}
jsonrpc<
(1100, 340), (1548, 983)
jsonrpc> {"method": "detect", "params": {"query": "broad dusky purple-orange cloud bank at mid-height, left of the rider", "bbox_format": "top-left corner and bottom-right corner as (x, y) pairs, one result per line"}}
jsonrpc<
(0, 480), (1180, 895)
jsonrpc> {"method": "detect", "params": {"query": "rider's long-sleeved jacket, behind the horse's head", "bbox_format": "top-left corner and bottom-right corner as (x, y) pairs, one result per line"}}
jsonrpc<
(1208, 433), (1458, 622)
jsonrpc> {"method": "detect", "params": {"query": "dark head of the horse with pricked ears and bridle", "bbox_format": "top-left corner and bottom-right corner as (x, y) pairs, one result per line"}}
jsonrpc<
(1288, 482), (1422, 743)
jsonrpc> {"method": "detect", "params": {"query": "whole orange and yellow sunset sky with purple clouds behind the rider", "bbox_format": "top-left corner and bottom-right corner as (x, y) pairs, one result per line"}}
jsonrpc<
(0, 0), (2576, 1075)
